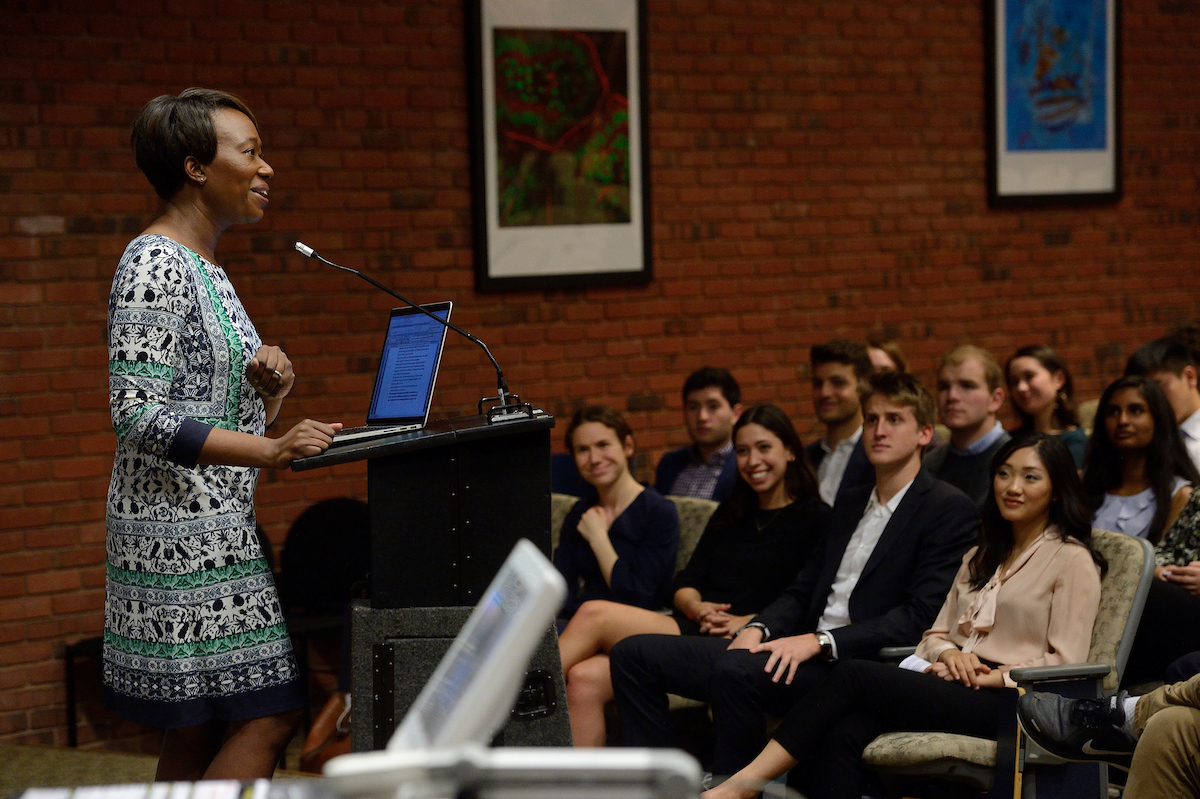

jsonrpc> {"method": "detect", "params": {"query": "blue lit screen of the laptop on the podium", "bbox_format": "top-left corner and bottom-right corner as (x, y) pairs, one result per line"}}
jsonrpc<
(367, 304), (450, 422)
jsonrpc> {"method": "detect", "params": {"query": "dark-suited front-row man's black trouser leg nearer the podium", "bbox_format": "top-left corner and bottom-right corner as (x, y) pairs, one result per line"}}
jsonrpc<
(608, 635), (730, 746)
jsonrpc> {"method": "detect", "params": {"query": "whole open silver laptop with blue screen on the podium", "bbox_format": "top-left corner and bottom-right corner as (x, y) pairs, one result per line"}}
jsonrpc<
(331, 302), (454, 446)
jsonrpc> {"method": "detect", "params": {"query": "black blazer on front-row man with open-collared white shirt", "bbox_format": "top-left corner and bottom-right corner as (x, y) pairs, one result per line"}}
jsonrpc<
(756, 471), (979, 660)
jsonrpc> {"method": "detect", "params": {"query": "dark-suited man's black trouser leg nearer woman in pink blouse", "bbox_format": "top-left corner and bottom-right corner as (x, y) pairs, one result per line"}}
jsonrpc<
(708, 649), (830, 775)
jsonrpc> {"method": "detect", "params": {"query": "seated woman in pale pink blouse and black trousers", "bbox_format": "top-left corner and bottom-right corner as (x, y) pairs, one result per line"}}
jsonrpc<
(704, 433), (1104, 799)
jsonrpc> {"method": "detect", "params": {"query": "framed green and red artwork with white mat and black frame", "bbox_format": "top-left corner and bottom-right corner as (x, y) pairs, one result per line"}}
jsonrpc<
(466, 0), (652, 290)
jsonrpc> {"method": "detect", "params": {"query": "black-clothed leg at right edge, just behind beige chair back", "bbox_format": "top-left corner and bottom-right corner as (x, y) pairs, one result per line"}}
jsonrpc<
(1121, 579), (1200, 686)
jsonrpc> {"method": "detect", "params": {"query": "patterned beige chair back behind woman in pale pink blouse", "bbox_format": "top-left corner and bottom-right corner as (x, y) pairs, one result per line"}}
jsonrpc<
(1087, 530), (1154, 691)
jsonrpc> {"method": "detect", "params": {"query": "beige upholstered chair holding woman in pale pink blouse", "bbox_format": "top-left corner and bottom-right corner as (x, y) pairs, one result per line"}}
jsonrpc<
(863, 530), (1154, 799)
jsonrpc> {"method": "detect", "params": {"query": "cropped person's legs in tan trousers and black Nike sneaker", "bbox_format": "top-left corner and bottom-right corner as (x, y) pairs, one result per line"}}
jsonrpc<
(1016, 653), (1200, 799)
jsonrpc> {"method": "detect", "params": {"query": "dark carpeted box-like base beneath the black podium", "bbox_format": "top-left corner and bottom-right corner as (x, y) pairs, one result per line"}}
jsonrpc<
(350, 601), (571, 752)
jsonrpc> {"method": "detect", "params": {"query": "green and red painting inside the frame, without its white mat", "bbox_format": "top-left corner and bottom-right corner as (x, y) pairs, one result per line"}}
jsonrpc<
(493, 28), (630, 228)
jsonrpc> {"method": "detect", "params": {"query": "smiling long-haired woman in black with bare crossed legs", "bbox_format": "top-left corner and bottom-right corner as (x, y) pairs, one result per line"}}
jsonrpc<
(558, 404), (829, 746)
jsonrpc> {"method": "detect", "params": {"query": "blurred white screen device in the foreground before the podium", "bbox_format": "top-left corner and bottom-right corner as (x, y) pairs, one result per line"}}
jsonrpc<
(324, 539), (700, 799)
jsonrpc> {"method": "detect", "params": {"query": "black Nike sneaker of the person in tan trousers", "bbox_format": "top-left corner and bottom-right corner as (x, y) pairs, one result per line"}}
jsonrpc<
(1016, 691), (1138, 771)
